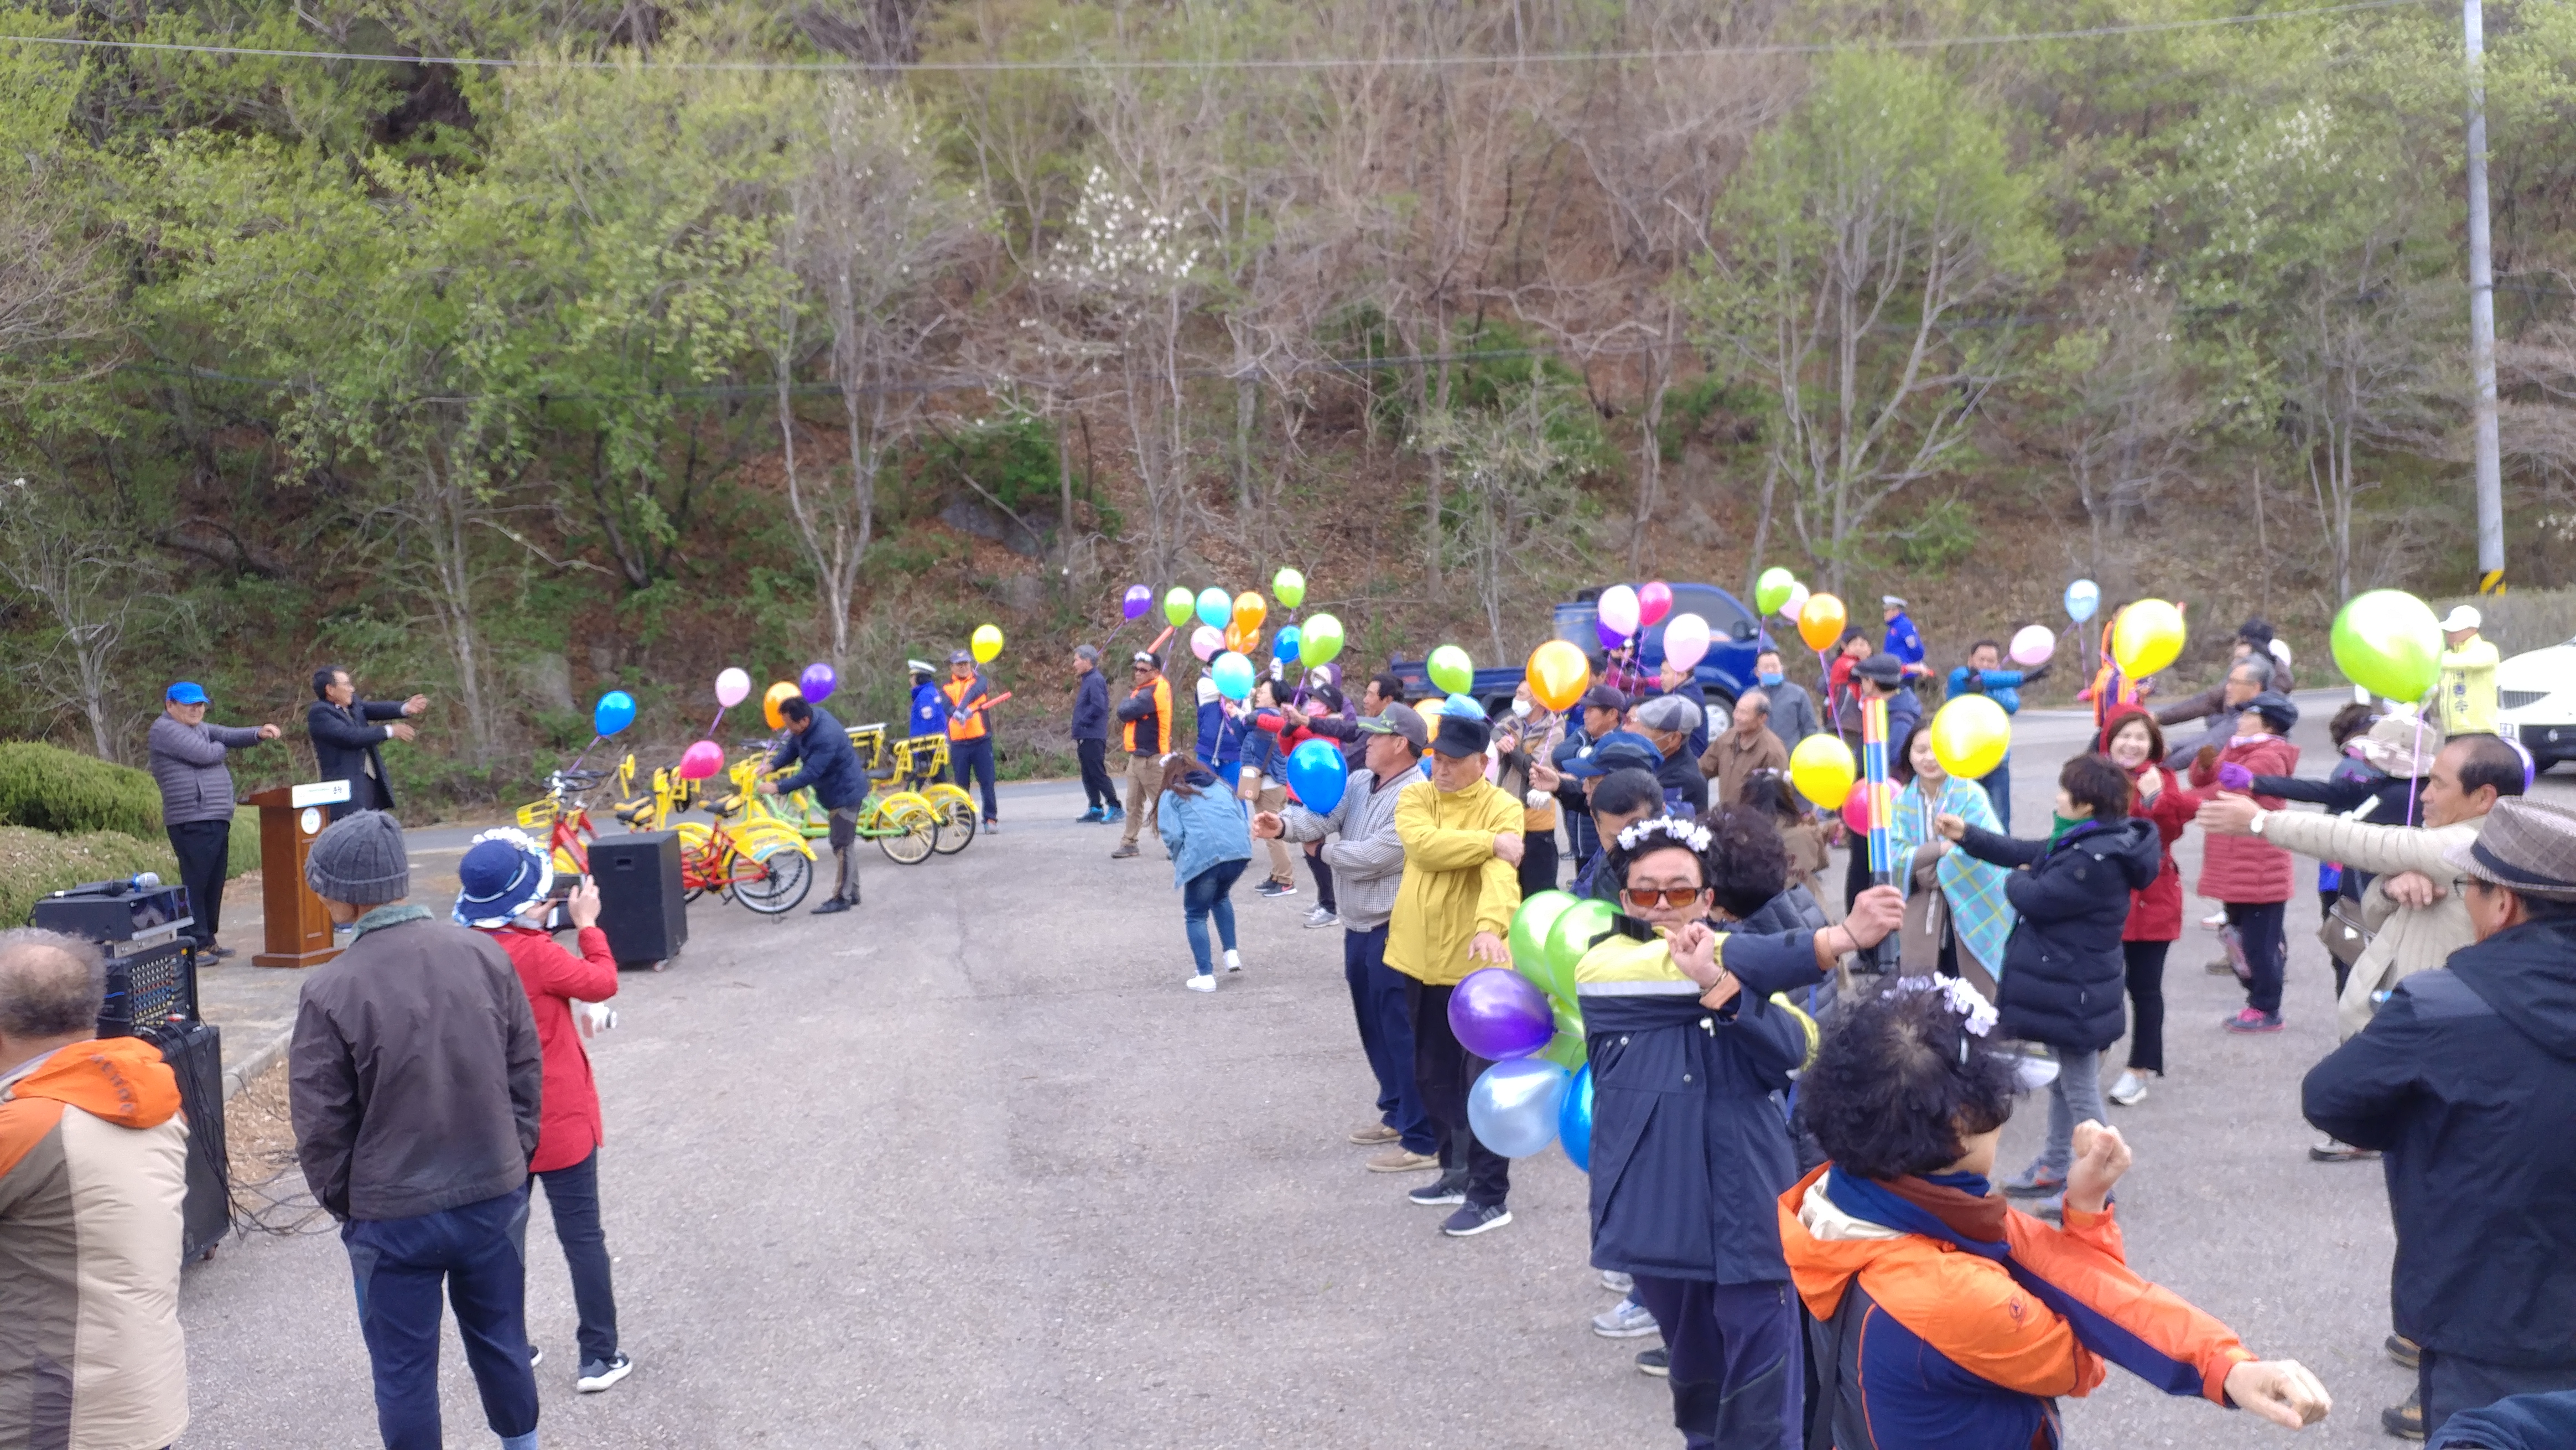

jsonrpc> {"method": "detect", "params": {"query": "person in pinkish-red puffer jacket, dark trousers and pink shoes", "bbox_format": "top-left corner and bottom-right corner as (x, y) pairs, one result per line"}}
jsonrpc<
(2192, 690), (2298, 1033)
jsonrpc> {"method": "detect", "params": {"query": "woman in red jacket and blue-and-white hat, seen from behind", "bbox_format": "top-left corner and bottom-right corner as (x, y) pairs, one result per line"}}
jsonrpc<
(456, 827), (633, 1394)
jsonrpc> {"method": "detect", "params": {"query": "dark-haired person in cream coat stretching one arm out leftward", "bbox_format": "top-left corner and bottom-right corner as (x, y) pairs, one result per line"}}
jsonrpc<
(2198, 734), (2525, 1038)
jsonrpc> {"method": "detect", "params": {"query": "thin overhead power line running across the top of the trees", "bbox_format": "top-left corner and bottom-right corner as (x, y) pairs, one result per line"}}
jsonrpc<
(0, 0), (2422, 75)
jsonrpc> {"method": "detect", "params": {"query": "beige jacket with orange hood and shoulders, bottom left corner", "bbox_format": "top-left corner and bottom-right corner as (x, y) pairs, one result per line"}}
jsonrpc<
(0, 1038), (188, 1450)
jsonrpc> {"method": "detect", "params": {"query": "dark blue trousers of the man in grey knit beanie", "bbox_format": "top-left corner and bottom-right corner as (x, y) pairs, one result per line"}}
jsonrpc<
(340, 1185), (536, 1450)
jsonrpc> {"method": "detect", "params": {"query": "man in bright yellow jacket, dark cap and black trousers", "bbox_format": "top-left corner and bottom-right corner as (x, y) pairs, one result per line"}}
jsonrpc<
(1386, 716), (1525, 1239)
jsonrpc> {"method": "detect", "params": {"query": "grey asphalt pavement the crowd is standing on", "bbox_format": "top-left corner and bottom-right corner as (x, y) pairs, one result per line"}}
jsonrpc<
(183, 703), (2473, 1450)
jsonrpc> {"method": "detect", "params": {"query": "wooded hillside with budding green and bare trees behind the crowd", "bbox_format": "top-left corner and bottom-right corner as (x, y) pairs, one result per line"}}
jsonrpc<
(0, 0), (2576, 799)
